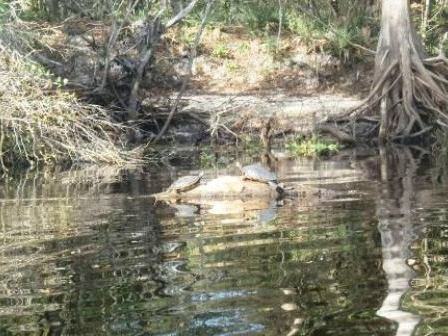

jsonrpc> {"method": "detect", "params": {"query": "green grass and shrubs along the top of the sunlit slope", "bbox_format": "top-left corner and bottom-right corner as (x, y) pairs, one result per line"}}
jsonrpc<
(184, 0), (377, 60)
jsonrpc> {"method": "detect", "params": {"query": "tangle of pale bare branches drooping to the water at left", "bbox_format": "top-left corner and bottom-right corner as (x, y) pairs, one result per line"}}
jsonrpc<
(0, 19), (142, 171)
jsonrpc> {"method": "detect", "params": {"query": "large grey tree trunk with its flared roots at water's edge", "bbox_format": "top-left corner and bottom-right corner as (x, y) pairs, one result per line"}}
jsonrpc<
(350, 0), (448, 142)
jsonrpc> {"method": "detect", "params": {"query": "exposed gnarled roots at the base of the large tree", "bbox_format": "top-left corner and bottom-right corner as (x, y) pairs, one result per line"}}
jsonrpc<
(344, 50), (448, 142)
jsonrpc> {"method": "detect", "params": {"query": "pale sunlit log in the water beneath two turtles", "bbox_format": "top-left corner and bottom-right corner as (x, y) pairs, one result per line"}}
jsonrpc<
(153, 176), (280, 201)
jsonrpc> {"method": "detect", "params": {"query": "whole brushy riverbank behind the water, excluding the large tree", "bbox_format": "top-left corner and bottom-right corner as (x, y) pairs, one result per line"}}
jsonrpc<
(0, 0), (448, 172)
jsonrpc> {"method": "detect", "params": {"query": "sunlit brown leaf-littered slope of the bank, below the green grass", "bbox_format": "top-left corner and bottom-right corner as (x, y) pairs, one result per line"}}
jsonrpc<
(165, 27), (370, 95)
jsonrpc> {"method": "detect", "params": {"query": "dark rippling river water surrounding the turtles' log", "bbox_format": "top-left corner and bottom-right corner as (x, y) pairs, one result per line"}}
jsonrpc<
(0, 149), (448, 336)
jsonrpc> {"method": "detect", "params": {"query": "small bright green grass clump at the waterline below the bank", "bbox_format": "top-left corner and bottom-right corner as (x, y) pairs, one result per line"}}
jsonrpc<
(286, 137), (340, 156)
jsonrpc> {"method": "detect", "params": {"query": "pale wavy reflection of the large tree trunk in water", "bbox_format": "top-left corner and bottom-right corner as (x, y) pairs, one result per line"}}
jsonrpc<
(377, 148), (421, 336)
